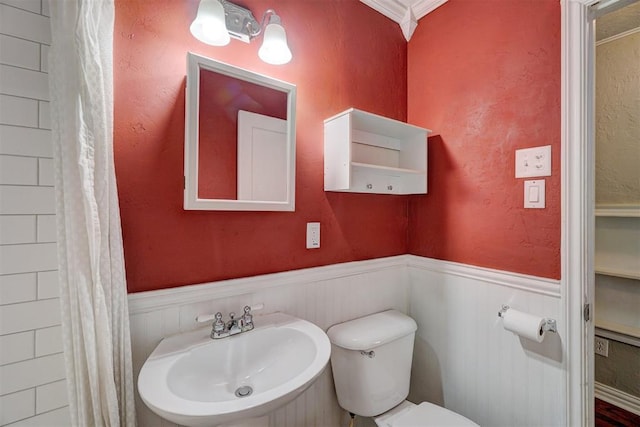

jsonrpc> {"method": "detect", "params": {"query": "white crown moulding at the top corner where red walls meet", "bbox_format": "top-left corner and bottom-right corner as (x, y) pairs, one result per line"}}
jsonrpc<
(360, 0), (447, 41)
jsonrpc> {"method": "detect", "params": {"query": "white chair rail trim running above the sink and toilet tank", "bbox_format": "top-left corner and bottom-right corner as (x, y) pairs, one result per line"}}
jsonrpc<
(129, 255), (407, 315)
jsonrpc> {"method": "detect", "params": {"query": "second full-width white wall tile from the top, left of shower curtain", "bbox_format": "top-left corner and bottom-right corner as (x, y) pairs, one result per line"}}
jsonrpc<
(0, 65), (49, 101)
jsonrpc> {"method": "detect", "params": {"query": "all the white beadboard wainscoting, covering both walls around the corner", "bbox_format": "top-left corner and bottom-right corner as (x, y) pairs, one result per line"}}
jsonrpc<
(129, 255), (566, 427)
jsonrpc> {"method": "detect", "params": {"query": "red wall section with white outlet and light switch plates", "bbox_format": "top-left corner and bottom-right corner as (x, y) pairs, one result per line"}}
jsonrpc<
(408, 0), (560, 279)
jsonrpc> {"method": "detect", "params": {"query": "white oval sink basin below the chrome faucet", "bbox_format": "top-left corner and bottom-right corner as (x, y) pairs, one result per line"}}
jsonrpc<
(138, 313), (331, 426)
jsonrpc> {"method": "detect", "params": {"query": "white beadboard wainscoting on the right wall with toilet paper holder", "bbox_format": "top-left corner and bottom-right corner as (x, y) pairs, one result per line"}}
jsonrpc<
(408, 257), (566, 427)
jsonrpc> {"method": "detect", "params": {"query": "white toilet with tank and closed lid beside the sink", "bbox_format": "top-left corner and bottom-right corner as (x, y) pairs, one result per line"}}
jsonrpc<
(327, 310), (478, 427)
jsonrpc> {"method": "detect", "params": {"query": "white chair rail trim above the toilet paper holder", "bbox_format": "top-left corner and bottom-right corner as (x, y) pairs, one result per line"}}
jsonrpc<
(407, 255), (560, 298)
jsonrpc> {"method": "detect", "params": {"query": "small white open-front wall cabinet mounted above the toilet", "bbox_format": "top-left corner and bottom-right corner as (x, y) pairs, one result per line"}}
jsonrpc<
(324, 108), (431, 194)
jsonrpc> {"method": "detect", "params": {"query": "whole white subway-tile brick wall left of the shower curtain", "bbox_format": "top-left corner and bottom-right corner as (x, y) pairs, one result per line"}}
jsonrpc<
(0, 0), (70, 426)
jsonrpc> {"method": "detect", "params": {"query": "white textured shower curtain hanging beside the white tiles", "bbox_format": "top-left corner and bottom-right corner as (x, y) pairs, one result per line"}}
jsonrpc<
(49, 0), (136, 427)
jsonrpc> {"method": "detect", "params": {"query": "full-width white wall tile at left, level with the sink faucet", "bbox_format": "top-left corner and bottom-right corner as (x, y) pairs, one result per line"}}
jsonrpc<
(0, 299), (60, 336)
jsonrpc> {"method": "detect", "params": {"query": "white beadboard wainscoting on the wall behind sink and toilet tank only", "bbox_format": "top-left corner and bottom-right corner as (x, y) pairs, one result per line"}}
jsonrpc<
(129, 256), (408, 427)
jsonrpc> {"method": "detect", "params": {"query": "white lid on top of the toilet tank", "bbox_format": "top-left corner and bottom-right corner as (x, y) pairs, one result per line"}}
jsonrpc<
(327, 310), (418, 350)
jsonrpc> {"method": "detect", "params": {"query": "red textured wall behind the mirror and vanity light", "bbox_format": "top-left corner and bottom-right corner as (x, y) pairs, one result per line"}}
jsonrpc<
(114, 0), (407, 292)
